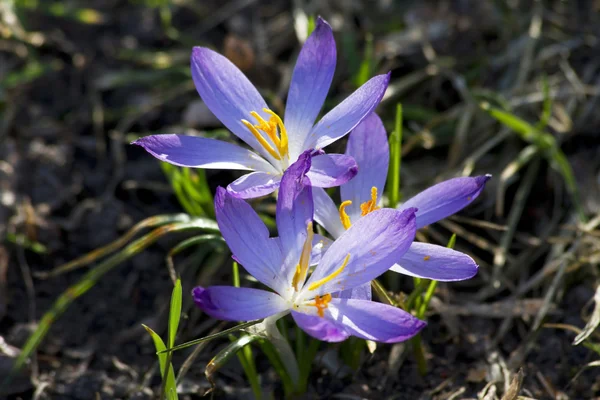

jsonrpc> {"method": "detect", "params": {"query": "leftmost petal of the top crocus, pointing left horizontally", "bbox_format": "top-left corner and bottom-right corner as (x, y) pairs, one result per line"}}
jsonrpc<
(132, 134), (276, 173)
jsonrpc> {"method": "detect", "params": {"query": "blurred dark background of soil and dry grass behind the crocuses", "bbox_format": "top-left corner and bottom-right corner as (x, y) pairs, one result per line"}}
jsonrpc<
(0, 0), (600, 400)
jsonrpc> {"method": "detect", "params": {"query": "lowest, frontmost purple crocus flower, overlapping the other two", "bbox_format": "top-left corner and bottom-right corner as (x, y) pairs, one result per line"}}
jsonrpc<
(193, 152), (425, 343)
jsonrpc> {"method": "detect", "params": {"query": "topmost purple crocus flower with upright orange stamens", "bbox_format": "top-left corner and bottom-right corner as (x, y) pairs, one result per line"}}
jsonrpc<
(134, 18), (390, 198)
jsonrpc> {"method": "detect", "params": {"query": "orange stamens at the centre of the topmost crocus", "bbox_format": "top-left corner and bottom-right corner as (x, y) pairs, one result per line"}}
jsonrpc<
(242, 108), (288, 161)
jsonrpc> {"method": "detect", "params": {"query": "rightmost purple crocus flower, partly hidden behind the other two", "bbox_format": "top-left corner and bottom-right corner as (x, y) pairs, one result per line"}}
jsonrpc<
(313, 113), (490, 298)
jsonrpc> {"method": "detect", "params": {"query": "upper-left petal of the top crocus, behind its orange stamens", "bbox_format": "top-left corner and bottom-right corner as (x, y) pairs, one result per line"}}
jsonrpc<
(191, 47), (273, 161)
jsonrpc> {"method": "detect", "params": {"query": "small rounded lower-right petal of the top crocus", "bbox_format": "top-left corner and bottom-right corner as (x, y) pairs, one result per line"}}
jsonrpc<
(307, 154), (358, 188)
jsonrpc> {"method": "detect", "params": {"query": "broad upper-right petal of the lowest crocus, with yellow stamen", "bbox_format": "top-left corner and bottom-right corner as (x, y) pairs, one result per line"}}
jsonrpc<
(298, 208), (416, 299)
